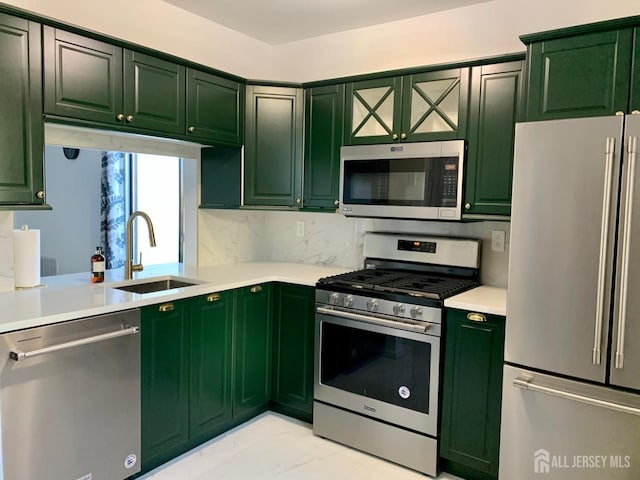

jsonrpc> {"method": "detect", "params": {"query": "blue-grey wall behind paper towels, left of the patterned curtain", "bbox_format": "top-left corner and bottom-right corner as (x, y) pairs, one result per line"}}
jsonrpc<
(14, 146), (102, 275)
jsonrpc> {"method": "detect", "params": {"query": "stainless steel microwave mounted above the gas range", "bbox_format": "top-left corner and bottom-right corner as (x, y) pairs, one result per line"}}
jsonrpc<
(340, 140), (465, 220)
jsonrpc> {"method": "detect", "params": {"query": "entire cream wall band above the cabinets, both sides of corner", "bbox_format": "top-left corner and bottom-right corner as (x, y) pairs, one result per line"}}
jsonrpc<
(3, 0), (640, 82)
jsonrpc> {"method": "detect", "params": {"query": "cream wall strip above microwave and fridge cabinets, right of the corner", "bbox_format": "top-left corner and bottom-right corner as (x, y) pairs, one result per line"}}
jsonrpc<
(273, 0), (640, 82)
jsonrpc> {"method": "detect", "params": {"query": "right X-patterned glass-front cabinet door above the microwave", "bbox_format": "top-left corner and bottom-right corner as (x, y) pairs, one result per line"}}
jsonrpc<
(399, 68), (469, 142)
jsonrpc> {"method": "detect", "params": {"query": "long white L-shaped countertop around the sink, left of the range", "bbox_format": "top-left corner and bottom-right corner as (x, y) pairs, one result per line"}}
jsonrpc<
(0, 262), (350, 333)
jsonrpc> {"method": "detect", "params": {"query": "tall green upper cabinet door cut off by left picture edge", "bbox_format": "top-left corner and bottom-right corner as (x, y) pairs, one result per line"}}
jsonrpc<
(0, 14), (44, 205)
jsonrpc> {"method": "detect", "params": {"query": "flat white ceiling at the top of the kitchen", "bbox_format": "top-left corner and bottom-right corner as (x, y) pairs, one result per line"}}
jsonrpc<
(164, 0), (490, 45)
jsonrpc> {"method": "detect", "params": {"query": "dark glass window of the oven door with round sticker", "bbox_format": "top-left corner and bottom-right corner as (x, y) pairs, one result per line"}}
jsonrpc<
(320, 322), (432, 414)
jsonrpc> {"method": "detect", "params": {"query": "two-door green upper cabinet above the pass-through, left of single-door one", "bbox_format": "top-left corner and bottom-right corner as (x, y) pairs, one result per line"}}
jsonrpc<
(44, 26), (185, 134)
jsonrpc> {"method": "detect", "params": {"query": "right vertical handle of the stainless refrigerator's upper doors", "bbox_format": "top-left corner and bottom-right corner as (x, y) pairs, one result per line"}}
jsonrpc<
(615, 137), (638, 370)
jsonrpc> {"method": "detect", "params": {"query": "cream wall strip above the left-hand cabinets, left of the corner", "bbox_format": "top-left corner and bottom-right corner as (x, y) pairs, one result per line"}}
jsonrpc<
(3, 0), (272, 78)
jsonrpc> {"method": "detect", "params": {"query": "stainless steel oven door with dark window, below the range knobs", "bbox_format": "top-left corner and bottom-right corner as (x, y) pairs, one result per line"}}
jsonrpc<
(314, 311), (440, 437)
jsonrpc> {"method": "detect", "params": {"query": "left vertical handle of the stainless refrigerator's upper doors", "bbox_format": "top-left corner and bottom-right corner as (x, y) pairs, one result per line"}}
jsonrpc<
(592, 137), (616, 365)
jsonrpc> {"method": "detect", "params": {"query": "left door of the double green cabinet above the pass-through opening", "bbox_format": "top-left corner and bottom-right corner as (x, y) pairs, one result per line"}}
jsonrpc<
(43, 26), (124, 124)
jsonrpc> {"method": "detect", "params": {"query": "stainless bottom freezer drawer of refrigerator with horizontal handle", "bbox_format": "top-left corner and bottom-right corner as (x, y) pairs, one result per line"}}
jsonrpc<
(499, 365), (640, 480)
